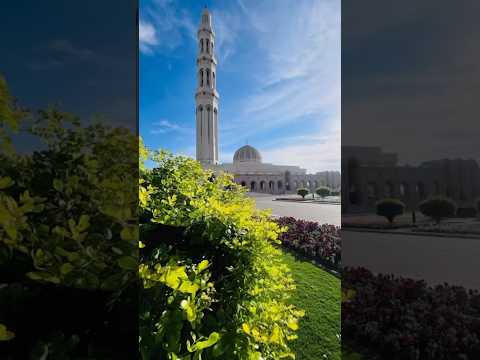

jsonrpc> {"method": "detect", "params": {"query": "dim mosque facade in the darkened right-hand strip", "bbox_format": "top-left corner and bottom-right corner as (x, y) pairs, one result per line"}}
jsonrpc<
(342, 146), (480, 214)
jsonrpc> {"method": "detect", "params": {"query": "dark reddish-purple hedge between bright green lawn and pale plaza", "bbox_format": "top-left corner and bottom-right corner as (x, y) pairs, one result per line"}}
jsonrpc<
(276, 217), (342, 269)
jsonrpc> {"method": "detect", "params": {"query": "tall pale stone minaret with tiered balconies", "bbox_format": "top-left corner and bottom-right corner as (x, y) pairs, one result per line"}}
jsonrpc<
(195, 7), (219, 165)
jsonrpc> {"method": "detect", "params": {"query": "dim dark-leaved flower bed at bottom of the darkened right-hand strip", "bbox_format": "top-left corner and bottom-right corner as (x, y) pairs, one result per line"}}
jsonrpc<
(342, 268), (480, 360)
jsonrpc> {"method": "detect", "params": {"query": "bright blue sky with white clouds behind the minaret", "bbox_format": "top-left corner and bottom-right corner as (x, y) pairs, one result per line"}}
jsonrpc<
(139, 0), (341, 172)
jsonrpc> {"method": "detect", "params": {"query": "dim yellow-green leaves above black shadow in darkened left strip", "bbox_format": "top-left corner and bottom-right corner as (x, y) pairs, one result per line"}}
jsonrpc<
(0, 78), (138, 290)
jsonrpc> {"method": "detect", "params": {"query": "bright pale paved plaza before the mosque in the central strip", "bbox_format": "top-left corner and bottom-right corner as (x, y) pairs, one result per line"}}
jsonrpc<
(249, 194), (341, 226)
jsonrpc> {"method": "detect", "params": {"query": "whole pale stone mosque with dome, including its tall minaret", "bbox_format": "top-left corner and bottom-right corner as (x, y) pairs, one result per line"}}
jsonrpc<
(195, 8), (341, 194)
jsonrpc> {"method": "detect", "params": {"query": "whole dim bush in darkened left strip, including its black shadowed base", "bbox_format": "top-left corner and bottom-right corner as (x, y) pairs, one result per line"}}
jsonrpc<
(0, 77), (138, 358)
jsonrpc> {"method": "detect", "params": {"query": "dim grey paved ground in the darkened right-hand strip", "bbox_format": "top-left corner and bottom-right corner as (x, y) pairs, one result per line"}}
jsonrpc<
(342, 229), (480, 289)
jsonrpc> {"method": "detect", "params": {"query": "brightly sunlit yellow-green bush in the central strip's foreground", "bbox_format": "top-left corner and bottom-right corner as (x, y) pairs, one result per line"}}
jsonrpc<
(139, 150), (302, 359)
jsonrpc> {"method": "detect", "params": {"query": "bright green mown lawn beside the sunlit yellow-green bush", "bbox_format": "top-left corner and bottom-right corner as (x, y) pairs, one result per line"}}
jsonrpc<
(283, 253), (341, 360)
